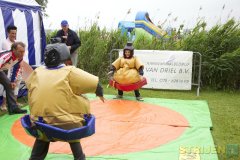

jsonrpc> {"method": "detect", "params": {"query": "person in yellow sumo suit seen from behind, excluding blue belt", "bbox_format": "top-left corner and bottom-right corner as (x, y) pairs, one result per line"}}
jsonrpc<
(26, 43), (105, 160)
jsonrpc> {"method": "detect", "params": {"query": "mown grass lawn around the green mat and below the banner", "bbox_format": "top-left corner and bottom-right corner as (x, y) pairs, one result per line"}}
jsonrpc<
(0, 85), (240, 160)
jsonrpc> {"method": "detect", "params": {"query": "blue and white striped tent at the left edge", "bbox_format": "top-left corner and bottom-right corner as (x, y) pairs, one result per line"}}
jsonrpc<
(0, 0), (46, 65)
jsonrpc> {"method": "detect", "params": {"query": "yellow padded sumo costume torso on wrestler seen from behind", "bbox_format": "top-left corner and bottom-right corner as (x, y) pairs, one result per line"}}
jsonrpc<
(26, 66), (98, 129)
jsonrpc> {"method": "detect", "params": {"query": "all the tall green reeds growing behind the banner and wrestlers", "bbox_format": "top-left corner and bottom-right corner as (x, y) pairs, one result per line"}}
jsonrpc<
(47, 19), (240, 90)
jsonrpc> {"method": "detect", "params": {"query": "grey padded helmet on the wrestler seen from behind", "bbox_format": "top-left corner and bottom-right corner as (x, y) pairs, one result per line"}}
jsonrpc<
(44, 43), (70, 68)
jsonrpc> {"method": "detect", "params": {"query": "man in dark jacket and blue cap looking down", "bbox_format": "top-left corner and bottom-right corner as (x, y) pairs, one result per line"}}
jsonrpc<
(55, 20), (81, 67)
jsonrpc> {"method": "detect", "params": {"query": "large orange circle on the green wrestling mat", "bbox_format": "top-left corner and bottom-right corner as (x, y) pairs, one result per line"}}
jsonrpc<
(12, 100), (188, 156)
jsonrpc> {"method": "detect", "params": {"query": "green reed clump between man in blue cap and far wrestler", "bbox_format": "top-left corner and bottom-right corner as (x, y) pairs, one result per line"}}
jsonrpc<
(78, 23), (127, 81)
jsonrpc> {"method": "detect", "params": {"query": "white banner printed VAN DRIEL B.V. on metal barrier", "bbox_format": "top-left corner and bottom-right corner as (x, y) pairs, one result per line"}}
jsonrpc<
(119, 50), (193, 90)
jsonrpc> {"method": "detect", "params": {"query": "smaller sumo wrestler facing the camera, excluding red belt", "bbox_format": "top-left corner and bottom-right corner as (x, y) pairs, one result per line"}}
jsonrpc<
(108, 42), (144, 101)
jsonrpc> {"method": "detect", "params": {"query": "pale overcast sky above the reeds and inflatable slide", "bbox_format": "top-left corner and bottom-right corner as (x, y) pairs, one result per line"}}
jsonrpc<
(44, 0), (240, 30)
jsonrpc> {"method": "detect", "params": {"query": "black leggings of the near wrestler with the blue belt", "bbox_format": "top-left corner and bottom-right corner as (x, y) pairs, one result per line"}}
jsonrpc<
(29, 139), (85, 160)
